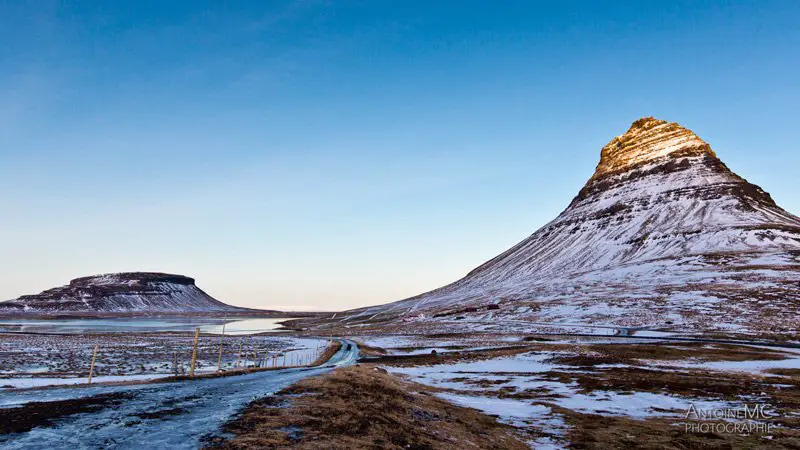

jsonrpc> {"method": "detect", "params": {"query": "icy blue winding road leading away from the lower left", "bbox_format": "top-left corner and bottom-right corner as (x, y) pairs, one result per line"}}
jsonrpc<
(0, 341), (358, 449)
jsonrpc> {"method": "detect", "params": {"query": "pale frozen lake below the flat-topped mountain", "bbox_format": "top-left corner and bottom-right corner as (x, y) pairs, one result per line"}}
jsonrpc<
(0, 317), (291, 334)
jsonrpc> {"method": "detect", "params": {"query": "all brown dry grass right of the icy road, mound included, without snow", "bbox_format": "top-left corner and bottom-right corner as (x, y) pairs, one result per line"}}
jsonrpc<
(208, 341), (800, 449)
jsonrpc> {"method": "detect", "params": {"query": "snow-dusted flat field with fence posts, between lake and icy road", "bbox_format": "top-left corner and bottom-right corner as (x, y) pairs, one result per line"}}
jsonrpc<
(0, 333), (328, 392)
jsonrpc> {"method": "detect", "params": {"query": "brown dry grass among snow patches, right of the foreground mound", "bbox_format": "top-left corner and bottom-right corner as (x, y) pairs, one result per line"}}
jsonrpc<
(374, 343), (800, 449)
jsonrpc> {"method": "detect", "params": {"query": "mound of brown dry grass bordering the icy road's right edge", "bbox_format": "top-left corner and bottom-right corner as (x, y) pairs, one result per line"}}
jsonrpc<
(210, 365), (528, 450)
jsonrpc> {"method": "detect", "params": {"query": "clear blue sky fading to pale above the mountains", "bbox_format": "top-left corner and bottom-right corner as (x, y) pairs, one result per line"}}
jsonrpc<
(0, 0), (800, 310)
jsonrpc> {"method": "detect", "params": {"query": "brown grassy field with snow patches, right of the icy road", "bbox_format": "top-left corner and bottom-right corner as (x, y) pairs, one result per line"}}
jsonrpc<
(214, 335), (800, 450)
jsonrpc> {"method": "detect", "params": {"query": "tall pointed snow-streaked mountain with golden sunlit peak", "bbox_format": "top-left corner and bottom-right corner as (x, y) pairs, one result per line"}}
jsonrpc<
(337, 117), (800, 333)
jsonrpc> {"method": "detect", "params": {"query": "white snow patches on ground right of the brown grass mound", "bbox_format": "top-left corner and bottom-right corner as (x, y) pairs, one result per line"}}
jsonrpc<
(384, 340), (800, 449)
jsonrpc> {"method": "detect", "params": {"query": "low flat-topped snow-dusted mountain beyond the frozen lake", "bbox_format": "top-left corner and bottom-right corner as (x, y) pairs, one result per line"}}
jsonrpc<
(0, 272), (247, 313)
